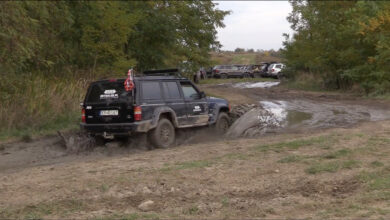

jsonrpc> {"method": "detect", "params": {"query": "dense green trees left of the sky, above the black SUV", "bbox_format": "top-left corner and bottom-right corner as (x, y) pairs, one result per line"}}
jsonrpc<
(0, 0), (228, 75)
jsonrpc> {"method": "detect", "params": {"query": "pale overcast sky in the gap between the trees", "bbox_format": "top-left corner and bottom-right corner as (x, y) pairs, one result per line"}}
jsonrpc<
(215, 1), (292, 50)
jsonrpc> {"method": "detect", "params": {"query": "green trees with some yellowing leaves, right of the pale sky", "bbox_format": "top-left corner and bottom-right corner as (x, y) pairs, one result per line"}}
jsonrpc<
(282, 0), (390, 94)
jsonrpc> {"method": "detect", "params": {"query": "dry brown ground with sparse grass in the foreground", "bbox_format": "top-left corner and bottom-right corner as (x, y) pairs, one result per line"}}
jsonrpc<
(0, 121), (390, 220)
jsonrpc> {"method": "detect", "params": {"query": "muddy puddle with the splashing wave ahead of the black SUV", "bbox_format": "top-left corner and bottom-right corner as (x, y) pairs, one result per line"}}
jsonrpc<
(227, 99), (390, 138)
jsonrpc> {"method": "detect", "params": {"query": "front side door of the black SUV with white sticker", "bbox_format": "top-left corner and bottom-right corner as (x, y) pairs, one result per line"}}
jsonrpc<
(180, 81), (209, 126)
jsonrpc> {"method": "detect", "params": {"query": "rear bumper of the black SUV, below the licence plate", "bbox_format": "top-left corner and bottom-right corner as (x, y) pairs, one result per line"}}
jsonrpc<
(80, 120), (153, 135)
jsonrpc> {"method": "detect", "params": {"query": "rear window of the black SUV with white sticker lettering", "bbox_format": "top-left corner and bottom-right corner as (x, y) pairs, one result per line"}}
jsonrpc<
(86, 80), (132, 102)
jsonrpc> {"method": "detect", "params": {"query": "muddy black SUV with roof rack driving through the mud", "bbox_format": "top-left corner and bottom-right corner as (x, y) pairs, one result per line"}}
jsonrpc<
(80, 69), (230, 147)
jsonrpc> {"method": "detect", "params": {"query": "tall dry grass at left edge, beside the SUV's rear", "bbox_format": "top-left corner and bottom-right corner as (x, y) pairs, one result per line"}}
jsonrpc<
(0, 74), (89, 139)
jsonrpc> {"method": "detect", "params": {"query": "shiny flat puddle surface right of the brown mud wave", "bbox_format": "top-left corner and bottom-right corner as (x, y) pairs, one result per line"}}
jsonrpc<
(260, 100), (390, 131)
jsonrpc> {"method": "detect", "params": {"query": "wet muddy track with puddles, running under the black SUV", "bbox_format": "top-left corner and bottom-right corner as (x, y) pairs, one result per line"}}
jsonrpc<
(0, 83), (390, 172)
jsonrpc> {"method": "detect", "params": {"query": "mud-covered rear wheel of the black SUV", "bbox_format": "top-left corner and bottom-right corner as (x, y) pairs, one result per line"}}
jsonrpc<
(148, 118), (175, 148)
